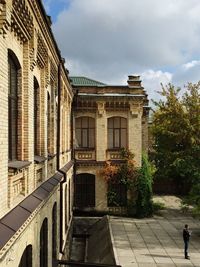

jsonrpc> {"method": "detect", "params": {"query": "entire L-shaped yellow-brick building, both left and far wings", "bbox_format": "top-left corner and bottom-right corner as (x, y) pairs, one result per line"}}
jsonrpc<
(0, 0), (148, 267)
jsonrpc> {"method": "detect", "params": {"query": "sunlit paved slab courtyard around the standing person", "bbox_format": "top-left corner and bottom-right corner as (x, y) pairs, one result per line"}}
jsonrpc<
(110, 197), (200, 267)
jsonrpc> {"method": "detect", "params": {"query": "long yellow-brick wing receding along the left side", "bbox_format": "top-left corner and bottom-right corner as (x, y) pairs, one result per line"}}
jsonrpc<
(0, 0), (73, 267)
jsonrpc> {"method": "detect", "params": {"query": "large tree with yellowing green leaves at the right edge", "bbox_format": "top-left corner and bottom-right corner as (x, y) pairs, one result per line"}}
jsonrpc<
(151, 82), (200, 193)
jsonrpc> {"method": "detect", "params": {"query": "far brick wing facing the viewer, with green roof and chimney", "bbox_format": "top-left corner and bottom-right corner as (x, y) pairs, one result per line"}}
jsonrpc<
(70, 76), (149, 215)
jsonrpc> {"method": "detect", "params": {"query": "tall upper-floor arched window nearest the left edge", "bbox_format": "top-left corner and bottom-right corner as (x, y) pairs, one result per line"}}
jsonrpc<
(8, 52), (19, 160)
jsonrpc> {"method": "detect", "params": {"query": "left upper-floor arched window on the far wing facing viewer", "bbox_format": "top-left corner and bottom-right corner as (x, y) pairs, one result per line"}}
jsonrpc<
(75, 117), (95, 148)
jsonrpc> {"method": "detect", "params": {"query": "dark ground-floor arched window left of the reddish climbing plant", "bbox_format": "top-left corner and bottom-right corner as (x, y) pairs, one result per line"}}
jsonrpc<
(75, 173), (95, 207)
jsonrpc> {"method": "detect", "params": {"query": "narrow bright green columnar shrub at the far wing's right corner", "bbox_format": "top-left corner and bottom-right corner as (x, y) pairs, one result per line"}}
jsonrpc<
(136, 153), (153, 218)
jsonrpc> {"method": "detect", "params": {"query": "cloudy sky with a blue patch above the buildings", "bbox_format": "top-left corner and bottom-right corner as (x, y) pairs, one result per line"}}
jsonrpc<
(43, 0), (200, 105)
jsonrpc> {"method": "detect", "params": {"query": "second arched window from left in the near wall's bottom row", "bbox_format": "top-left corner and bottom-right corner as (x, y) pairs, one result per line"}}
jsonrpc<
(40, 218), (48, 267)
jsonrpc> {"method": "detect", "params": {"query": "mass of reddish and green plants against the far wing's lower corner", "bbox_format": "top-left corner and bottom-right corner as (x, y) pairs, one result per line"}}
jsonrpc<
(101, 149), (153, 217)
